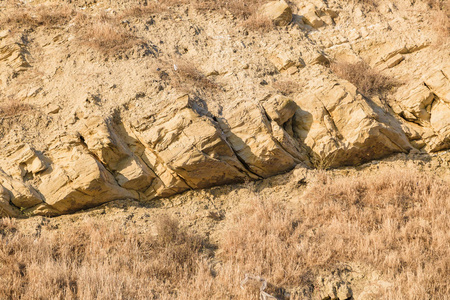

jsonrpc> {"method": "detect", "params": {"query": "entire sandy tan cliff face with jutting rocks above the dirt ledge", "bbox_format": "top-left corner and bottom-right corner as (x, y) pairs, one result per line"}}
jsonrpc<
(0, 1), (450, 216)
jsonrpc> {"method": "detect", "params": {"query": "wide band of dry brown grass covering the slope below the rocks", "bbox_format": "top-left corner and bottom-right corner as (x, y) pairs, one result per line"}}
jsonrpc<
(0, 169), (450, 299)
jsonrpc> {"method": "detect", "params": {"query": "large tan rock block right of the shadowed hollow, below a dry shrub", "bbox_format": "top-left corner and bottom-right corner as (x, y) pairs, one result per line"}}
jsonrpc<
(293, 79), (412, 167)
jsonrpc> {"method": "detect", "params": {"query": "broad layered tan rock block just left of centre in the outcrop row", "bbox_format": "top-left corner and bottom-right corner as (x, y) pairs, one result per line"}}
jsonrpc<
(130, 96), (253, 190)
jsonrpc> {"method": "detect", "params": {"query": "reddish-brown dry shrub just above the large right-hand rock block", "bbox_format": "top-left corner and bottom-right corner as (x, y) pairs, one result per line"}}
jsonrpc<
(330, 61), (396, 96)
